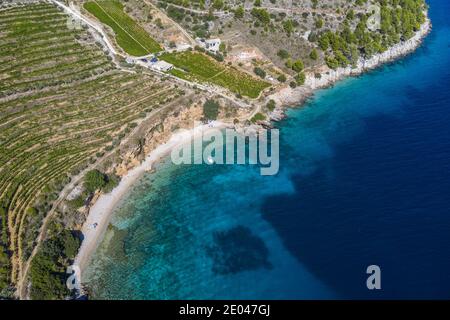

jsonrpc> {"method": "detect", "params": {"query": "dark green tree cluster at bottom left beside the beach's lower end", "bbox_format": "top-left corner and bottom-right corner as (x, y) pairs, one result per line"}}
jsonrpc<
(30, 230), (81, 300)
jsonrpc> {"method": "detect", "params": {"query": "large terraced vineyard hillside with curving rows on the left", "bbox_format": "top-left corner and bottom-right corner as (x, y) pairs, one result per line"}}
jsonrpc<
(0, 2), (180, 287)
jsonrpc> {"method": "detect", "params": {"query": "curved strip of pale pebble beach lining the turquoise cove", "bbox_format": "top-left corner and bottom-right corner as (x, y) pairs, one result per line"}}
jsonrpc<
(74, 121), (227, 281)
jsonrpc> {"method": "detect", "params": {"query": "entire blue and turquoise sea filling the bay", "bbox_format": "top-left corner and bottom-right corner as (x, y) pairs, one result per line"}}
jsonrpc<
(86, 0), (450, 299)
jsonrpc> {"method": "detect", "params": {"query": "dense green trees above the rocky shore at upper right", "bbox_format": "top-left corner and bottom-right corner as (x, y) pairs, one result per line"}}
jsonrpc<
(318, 0), (425, 69)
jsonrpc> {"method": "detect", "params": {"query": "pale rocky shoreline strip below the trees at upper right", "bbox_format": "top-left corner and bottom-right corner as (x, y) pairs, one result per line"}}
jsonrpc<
(271, 17), (431, 107)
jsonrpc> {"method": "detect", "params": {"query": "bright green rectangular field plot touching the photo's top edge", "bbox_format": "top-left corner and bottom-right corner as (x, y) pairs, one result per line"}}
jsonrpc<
(84, 0), (161, 56)
